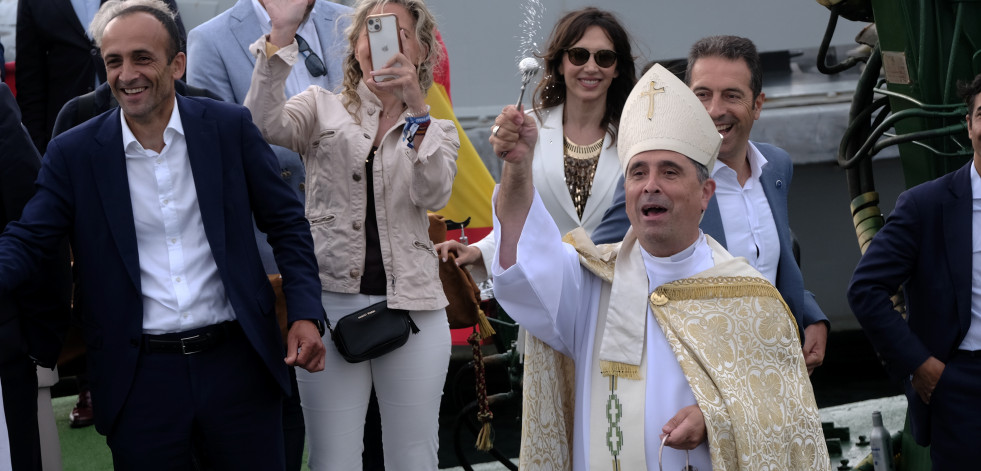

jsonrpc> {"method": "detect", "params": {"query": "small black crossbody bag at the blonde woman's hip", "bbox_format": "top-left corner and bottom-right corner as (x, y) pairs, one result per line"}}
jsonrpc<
(327, 301), (419, 363)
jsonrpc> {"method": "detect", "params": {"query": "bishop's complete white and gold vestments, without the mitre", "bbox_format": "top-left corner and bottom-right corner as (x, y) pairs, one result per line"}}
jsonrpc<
(492, 188), (830, 471)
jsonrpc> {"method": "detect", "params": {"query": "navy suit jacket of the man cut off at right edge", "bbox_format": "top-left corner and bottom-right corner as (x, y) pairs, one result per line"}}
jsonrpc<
(848, 162), (974, 445)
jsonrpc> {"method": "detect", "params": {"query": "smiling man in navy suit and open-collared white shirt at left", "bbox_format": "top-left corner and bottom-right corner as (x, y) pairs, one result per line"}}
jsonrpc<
(0, 0), (324, 470)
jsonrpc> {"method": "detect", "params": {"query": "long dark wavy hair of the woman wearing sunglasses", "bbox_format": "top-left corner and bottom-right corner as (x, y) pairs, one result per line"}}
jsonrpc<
(534, 7), (637, 143)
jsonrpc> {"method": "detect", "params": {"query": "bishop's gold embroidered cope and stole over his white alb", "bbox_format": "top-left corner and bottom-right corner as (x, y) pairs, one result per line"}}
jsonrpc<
(521, 230), (831, 470)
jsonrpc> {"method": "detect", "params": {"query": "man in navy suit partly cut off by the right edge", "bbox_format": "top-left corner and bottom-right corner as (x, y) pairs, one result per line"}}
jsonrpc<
(848, 75), (981, 470)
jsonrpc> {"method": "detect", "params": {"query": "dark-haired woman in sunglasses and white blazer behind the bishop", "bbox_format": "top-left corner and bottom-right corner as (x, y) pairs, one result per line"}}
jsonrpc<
(437, 7), (637, 280)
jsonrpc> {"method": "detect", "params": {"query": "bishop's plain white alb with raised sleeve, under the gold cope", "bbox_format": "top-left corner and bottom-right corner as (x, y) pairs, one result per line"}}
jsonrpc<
(492, 193), (712, 471)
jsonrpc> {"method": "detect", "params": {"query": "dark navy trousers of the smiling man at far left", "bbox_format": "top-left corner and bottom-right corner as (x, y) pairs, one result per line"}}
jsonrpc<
(106, 329), (285, 471)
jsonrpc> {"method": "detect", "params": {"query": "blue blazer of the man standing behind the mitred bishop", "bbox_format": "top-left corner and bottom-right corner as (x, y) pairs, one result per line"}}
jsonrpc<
(593, 142), (828, 329)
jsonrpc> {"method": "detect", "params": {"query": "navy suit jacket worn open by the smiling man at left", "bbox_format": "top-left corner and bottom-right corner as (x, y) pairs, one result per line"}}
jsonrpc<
(0, 95), (323, 434)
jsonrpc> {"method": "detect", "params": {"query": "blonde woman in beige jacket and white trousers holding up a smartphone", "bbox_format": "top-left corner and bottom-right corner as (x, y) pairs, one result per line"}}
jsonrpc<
(245, 0), (459, 471)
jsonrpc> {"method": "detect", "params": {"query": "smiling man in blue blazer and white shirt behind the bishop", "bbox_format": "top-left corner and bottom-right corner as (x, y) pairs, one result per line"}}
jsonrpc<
(593, 36), (830, 373)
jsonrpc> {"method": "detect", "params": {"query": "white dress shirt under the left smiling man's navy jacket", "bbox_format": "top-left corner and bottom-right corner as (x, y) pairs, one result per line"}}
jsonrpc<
(119, 98), (235, 334)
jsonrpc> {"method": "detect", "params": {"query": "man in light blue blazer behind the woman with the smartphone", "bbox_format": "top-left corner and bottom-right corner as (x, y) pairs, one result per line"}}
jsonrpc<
(187, 0), (351, 470)
